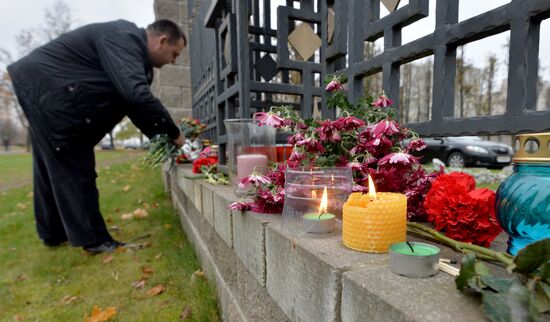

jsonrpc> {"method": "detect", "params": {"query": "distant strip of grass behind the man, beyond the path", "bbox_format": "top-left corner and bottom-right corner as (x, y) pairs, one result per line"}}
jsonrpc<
(0, 150), (145, 186)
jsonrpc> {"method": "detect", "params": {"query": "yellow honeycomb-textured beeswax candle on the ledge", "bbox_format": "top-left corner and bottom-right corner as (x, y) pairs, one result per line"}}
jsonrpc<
(342, 189), (407, 253)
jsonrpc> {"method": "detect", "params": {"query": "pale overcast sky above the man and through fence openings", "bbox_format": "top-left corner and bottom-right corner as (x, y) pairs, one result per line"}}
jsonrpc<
(0, 0), (550, 79)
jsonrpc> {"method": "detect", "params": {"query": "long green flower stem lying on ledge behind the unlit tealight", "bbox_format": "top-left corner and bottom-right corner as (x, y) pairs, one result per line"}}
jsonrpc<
(407, 222), (514, 267)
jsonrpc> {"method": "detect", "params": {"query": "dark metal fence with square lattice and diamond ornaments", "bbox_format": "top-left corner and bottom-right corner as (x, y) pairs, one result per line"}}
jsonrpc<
(190, 0), (550, 163)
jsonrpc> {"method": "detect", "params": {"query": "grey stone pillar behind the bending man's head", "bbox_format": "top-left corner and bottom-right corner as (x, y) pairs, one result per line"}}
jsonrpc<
(152, 0), (192, 121)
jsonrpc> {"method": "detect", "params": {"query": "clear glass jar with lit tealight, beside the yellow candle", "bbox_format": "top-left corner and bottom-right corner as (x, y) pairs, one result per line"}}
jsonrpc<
(281, 167), (352, 235)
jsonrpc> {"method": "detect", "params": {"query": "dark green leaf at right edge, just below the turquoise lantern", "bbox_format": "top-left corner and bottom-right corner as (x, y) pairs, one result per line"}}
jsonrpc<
(513, 238), (550, 275)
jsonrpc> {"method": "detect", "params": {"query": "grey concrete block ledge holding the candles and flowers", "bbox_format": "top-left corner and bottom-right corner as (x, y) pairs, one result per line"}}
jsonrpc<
(168, 166), (486, 322)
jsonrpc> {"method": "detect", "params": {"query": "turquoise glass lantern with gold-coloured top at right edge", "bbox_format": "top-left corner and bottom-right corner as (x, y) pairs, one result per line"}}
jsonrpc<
(496, 133), (550, 255)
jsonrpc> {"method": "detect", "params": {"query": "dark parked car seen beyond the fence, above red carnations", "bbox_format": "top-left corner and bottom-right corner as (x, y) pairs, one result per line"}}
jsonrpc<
(414, 136), (513, 169)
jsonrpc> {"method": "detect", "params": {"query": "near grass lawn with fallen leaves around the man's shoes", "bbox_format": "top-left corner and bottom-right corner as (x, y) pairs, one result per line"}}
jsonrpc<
(0, 161), (220, 321)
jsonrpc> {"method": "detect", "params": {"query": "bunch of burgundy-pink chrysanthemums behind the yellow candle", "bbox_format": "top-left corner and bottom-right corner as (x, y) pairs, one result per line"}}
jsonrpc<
(232, 76), (441, 220)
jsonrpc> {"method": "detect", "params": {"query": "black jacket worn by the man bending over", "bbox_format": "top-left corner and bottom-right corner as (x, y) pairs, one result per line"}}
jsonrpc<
(8, 20), (179, 150)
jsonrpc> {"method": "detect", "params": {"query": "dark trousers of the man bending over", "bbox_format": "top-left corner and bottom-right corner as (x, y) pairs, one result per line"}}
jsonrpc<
(31, 125), (112, 246)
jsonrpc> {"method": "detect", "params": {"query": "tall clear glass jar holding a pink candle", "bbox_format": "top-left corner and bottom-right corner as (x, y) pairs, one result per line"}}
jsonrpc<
(223, 119), (277, 185)
